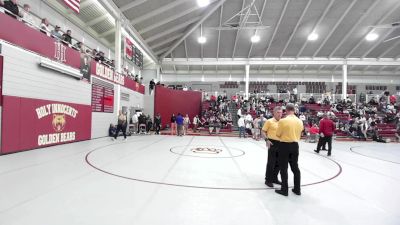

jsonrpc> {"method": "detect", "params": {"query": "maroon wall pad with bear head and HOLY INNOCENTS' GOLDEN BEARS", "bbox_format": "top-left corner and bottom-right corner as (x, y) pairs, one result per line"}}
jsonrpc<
(1, 96), (92, 154)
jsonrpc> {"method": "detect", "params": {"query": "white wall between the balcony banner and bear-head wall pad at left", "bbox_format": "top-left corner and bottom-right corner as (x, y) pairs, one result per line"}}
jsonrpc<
(0, 42), (91, 105)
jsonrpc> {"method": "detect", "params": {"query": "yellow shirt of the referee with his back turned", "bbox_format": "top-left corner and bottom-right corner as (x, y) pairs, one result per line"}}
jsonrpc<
(276, 115), (304, 142)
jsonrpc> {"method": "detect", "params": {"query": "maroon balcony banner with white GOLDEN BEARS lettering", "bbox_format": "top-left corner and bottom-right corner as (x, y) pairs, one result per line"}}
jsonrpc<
(90, 60), (145, 94)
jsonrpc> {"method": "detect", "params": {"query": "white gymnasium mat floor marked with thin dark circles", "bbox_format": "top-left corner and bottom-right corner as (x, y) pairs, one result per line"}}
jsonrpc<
(0, 136), (400, 225)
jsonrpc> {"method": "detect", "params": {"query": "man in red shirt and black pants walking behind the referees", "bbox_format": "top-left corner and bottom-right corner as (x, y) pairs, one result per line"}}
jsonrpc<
(314, 113), (335, 156)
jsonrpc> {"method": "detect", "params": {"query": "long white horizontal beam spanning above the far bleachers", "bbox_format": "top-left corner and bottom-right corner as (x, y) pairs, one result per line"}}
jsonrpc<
(161, 58), (400, 66)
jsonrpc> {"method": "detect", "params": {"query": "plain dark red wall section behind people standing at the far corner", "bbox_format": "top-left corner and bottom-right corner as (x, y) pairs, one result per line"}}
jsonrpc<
(154, 86), (201, 127)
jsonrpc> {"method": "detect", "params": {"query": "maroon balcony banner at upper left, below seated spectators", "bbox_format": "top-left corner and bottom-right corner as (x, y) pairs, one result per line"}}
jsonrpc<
(0, 13), (81, 69)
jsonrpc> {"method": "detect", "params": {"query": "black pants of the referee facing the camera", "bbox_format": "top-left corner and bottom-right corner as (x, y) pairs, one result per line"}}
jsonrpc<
(265, 139), (280, 183)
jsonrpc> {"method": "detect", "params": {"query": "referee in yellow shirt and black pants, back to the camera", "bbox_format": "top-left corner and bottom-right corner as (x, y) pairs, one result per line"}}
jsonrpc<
(275, 103), (304, 196)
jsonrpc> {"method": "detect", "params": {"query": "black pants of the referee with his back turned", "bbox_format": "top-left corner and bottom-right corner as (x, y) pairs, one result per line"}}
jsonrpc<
(278, 142), (301, 193)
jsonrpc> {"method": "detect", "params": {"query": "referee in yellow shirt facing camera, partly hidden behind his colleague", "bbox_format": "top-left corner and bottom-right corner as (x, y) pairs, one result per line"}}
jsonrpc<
(262, 106), (282, 187)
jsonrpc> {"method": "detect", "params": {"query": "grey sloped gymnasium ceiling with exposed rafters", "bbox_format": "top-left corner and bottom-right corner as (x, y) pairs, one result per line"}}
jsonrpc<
(53, 0), (400, 74)
